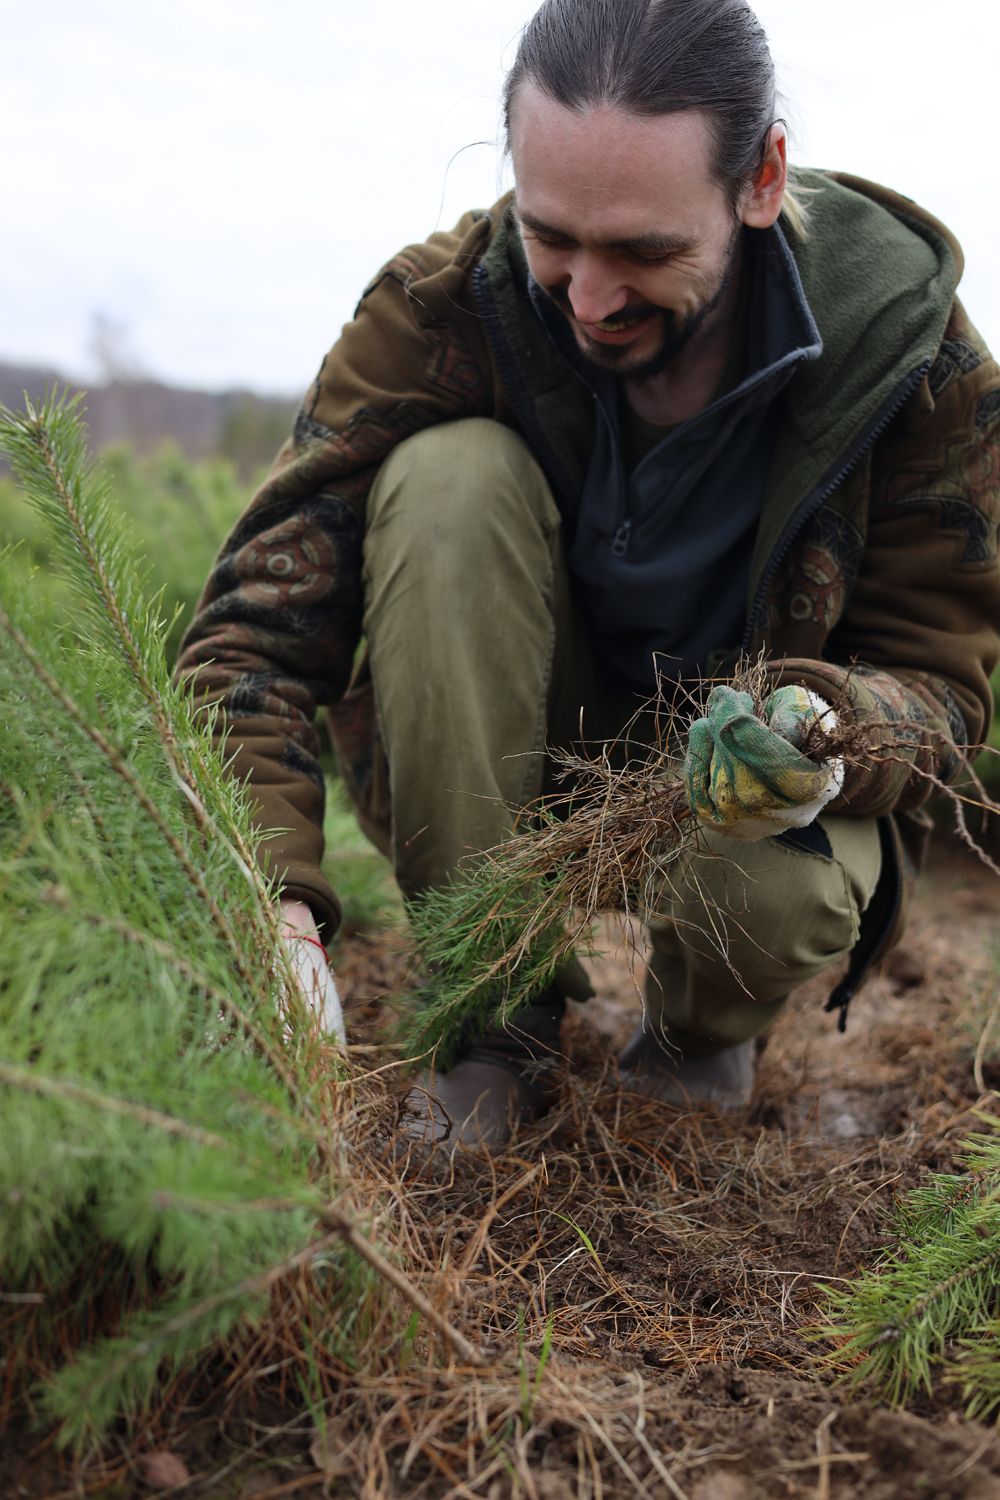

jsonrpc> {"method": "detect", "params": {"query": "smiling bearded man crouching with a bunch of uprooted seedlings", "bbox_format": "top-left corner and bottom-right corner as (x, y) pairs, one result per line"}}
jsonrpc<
(181, 0), (1000, 1143)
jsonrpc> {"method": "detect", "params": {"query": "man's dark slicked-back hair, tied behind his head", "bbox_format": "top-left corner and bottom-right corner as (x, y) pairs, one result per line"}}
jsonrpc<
(504, 0), (775, 201)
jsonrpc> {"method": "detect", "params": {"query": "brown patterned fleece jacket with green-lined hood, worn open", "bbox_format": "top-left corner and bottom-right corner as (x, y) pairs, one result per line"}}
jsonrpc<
(178, 173), (1000, 954)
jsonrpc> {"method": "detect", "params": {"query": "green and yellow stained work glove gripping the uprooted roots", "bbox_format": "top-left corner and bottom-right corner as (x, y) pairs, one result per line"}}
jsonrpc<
(684, 687), (844, 840)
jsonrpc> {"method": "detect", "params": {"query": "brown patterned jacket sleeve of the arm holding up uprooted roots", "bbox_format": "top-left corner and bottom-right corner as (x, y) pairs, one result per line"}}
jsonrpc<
(775, 308), (1000, 816)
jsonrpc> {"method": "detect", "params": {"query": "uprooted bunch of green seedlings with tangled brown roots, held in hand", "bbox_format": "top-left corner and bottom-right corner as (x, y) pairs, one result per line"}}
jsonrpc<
(403, 659), (871, 1067)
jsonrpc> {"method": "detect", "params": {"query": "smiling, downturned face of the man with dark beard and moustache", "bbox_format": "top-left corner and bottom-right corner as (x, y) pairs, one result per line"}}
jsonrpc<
(511, 83), (741, 380)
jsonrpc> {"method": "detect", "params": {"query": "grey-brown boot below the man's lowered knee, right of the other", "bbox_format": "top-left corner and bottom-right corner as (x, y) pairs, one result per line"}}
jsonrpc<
(618, 1023), (756, 1112)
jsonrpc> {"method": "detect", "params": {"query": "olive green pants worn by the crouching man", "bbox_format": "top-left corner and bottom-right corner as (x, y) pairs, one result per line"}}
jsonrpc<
(364, 419), (880, 1052)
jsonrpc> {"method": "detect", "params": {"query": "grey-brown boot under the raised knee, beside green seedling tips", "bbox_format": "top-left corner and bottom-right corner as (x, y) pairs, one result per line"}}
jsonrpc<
(399, 992), (565, 1149)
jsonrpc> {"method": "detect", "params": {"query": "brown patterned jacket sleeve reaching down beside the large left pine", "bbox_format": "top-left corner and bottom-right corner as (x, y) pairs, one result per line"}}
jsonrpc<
(177, 216), (490, 930)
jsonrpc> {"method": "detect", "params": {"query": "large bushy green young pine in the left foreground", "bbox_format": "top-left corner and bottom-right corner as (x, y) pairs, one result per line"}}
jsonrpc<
(0, 401), (371, 1442)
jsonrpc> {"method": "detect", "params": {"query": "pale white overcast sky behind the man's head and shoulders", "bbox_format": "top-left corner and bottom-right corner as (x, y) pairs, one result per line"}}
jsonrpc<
(0, 0), (1000, 395)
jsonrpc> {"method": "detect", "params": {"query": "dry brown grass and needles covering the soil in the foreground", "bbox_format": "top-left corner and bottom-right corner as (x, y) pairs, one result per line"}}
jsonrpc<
(17, 942), (1000, 1500)
